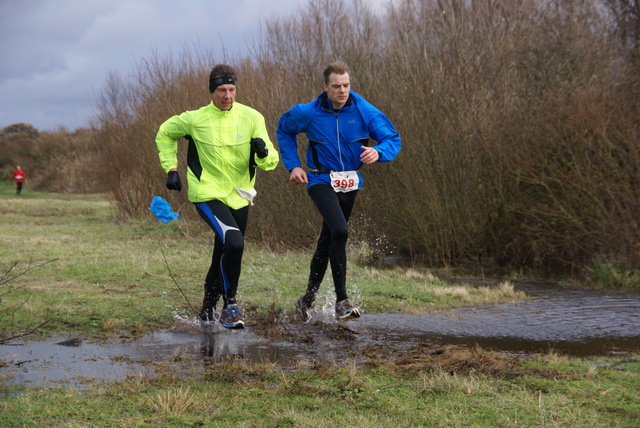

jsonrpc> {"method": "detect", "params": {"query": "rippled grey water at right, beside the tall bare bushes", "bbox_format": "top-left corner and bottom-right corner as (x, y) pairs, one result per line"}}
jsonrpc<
(362, 284), (640, 356)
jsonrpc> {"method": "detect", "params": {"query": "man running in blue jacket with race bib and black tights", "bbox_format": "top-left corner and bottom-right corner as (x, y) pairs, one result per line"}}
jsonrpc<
(276, 62), (401, 321)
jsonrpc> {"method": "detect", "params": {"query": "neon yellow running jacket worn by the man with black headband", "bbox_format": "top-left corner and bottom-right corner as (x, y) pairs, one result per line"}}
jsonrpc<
(156, 102), (280, 209)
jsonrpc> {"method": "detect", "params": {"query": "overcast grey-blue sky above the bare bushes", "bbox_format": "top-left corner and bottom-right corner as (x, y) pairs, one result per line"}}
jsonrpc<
(0, 0), (387, 131)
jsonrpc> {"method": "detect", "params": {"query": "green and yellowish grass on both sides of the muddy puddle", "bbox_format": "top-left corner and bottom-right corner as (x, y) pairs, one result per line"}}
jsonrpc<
(0, 186), (640, 427)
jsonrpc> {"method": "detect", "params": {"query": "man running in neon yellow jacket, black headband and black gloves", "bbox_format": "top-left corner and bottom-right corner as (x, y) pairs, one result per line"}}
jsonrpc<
(156, 64), (280, 328)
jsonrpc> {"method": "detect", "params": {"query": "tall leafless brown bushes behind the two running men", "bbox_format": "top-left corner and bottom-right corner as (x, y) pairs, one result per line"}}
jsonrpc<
(98, 0), (640, 276)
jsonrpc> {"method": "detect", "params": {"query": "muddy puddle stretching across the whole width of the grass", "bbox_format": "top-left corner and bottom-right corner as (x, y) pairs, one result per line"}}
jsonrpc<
(0, 284), (640, 389)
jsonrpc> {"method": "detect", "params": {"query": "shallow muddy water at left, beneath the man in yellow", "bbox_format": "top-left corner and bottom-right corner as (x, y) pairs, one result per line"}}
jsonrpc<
(0, 328), (298, 389)
